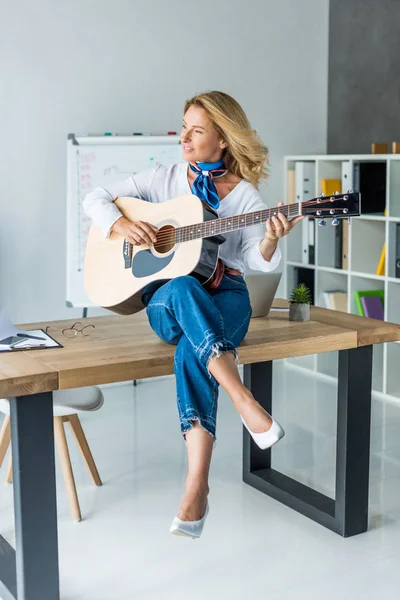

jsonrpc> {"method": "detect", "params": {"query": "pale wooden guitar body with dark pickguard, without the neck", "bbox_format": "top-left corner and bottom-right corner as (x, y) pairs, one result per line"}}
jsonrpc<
(85, 194), (225, 315)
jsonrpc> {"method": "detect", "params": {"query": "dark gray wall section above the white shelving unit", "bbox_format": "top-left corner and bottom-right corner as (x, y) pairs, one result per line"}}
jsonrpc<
(328, 0), (400, 154)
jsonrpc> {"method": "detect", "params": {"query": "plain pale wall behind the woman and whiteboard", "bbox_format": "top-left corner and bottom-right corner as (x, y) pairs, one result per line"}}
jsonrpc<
(0, 0), (328, 323)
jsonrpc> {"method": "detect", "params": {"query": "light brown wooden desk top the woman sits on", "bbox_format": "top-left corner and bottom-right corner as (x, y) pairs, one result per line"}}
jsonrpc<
(0, 299), (400, 398)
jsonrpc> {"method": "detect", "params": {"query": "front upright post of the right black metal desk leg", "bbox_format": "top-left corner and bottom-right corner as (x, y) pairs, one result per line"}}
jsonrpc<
(335, 346), (372, 537)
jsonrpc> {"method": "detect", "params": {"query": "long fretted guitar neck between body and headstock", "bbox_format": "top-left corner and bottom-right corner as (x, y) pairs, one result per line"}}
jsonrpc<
(175, 202), (303, 242)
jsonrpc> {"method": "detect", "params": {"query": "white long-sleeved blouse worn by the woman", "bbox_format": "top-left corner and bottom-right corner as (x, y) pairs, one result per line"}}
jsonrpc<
(83, 162), (281, 273)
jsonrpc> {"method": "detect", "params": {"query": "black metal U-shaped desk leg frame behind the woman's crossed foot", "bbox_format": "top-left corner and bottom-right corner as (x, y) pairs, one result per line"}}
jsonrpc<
(243, 346), (372, 537)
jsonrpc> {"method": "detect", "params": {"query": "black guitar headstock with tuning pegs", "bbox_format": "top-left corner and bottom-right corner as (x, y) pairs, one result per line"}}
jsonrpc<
(302, 190), (361, 225)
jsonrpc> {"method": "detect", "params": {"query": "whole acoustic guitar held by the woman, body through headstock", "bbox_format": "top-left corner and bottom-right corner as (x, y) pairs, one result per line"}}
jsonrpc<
(84, 191), (361, 315)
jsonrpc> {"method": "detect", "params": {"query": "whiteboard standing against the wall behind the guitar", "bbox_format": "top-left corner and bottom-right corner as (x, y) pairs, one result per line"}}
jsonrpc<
(66, 134), (182, 307)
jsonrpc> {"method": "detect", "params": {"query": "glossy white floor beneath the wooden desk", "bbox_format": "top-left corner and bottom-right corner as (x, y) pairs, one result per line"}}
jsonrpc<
(0, 362), (400, 600)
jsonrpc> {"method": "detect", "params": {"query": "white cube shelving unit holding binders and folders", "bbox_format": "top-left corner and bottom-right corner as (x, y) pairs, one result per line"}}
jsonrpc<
(283, 154), (400, 401)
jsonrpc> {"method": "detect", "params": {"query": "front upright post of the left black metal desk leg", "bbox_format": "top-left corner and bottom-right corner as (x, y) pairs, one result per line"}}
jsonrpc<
(11, 392), (60, 600)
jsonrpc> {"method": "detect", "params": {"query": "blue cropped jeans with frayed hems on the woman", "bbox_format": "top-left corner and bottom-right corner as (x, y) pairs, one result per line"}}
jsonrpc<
(144, 275), (251, 440)
